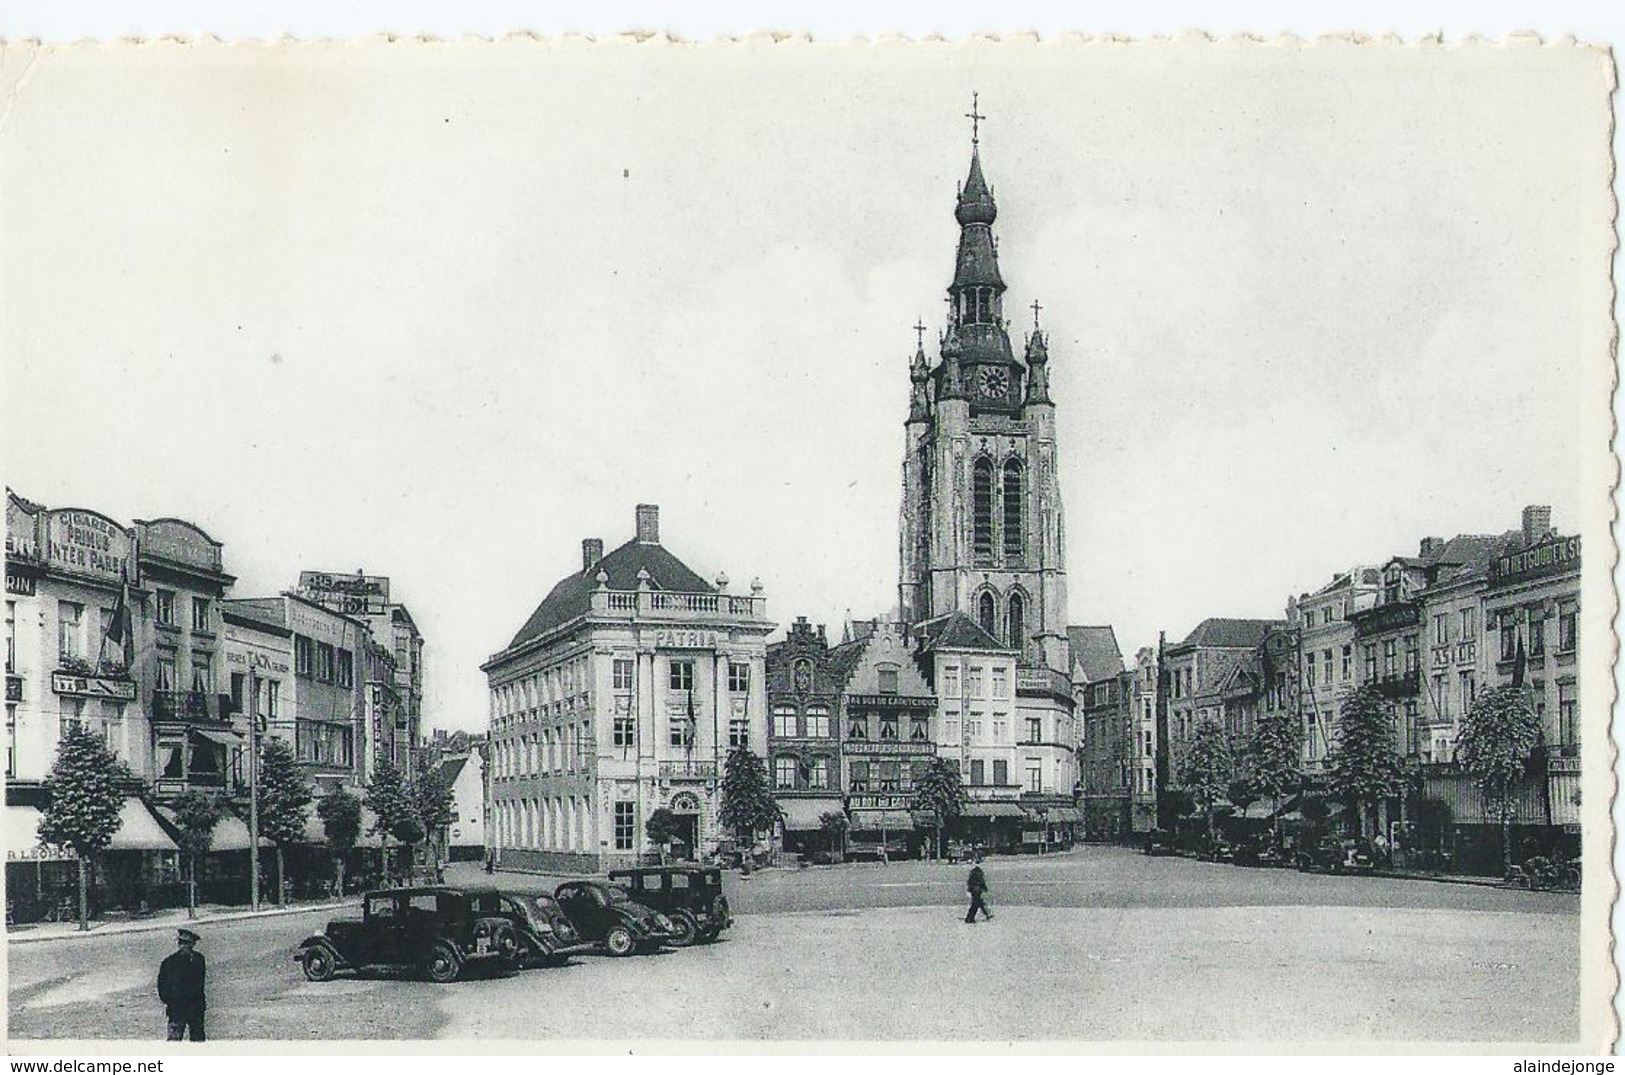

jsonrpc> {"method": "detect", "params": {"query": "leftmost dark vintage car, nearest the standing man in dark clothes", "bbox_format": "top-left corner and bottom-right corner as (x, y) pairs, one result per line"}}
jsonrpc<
(294, 885), (536, 982)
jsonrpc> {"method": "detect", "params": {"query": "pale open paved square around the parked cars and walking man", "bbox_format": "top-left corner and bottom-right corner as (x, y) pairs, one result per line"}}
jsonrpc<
(10, 848), (1580, 1044)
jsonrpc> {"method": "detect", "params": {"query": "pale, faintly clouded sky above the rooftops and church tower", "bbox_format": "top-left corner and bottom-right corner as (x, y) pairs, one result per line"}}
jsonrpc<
(0, 41), (1609, 727)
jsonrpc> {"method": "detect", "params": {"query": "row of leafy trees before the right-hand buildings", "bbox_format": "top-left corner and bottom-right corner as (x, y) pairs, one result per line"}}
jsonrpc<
(1180, 684), (1542, 864)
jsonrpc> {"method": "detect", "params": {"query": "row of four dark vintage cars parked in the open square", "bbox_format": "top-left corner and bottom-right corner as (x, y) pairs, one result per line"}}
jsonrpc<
(294, 867), (733, 982)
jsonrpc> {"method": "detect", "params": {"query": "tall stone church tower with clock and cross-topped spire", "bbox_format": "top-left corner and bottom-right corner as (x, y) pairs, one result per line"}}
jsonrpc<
(899, 106), (1069, 674)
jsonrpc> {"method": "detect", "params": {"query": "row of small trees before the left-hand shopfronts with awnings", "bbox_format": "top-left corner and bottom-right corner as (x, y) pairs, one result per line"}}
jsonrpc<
(39, 724), (452, 929)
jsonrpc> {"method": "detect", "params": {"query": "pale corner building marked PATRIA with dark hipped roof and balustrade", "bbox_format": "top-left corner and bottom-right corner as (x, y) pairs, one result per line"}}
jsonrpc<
(481, 505), (774, 870)
